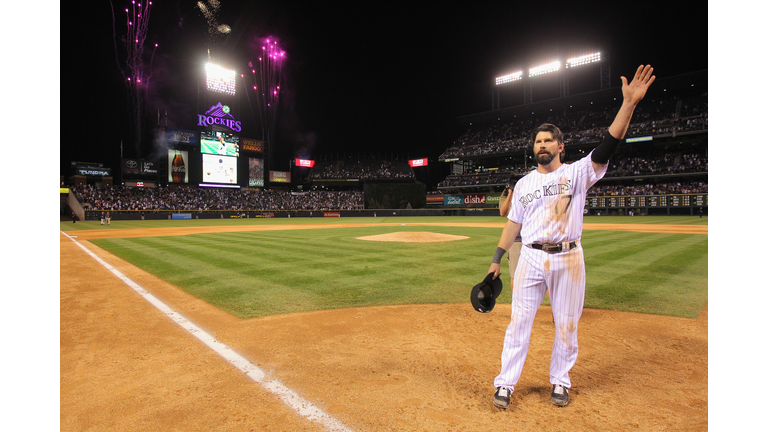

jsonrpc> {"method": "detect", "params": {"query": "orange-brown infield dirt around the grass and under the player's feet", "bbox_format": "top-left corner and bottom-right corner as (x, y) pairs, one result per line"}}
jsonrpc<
(60, 224), (708, 432)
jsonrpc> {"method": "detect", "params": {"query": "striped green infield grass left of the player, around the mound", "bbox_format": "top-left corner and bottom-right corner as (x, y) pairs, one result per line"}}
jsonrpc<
(94, 227), (509, 318)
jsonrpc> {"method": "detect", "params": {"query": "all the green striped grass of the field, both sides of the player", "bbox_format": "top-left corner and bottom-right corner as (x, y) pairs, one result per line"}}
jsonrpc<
(61, 216), (708, 318)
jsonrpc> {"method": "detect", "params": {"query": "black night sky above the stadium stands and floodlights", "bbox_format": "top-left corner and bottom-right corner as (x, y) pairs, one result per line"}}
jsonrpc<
(61, 0), (707, 178)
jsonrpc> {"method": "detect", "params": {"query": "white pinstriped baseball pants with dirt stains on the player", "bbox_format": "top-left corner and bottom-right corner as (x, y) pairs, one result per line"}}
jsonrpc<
(493, 241), (586, 391)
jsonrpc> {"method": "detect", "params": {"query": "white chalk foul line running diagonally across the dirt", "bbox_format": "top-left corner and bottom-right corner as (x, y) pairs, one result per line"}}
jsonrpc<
(61, 231), (352, 432)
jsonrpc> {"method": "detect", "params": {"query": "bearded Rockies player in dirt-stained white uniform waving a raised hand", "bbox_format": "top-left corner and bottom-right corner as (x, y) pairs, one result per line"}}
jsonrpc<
(488, 65), (656, 409)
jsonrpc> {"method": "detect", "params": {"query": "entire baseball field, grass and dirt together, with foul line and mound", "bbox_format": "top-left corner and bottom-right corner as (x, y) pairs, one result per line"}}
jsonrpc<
(60, 216), (708, 431)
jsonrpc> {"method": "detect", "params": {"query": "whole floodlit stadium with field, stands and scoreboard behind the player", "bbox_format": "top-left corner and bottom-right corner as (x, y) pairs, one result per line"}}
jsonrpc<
(59, 2), (709, 431)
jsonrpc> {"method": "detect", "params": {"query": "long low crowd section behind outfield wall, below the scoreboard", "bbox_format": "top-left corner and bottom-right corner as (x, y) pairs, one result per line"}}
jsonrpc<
(72, 185), (364, 211)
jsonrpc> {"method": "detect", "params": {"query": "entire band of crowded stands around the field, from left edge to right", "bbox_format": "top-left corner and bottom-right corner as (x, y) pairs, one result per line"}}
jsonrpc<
(62, 70), (708, 220)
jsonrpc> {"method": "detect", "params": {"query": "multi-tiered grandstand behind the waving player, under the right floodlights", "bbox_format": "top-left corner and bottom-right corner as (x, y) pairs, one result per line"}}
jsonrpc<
(428, 70), (708, 214)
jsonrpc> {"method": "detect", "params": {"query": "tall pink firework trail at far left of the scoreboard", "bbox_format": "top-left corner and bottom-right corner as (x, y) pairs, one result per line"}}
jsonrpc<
(109, 0), (157, 156)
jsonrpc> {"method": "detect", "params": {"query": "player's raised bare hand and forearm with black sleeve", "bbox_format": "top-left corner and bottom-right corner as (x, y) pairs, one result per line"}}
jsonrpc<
(592, 65), (656, 171)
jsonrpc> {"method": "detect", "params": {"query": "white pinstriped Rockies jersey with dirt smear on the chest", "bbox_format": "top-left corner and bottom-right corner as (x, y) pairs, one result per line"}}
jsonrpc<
(507, 152), (608, 245)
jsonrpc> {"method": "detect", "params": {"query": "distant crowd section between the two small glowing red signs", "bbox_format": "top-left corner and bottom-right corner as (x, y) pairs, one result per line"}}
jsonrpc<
(309, 160), (414, 180)
